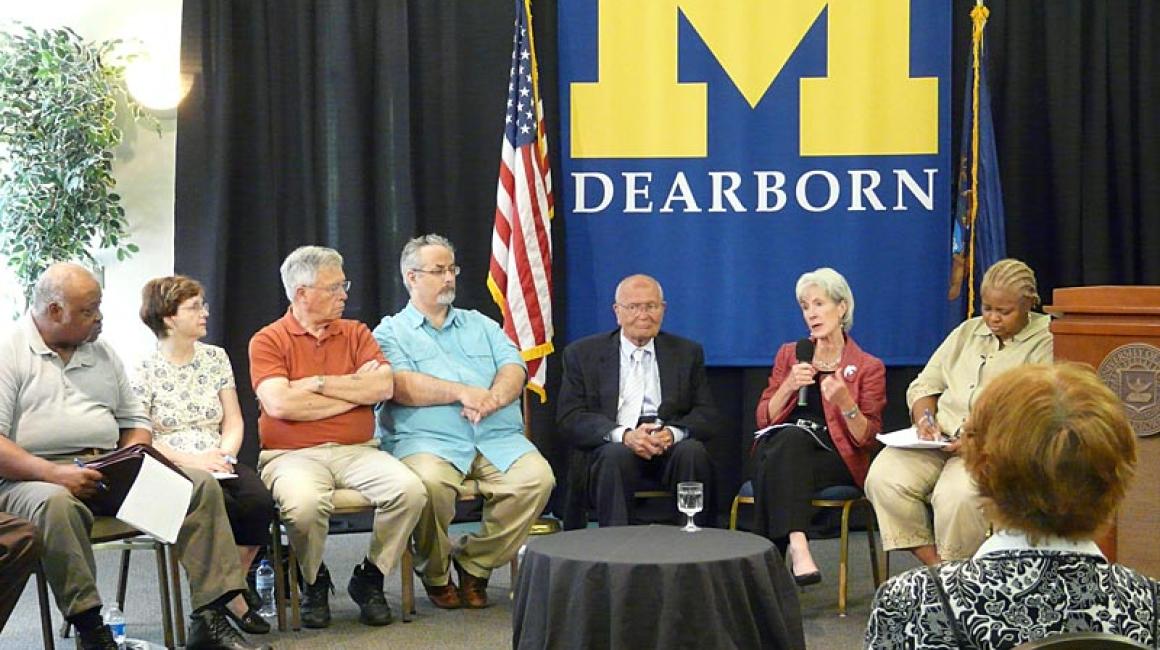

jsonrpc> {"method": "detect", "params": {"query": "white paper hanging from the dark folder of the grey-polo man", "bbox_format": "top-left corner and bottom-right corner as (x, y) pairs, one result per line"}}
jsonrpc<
(117, 455), (194, 544)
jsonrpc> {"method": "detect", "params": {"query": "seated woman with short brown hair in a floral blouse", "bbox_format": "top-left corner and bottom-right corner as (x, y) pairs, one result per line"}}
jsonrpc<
(133, 275), (274, 634)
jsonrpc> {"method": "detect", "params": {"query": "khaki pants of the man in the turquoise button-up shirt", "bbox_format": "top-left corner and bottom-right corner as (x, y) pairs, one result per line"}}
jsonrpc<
(403, 452), (556, 586)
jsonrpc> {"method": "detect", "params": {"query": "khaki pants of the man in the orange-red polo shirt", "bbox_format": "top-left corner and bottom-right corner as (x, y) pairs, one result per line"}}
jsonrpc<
(259, 440), (427, 584)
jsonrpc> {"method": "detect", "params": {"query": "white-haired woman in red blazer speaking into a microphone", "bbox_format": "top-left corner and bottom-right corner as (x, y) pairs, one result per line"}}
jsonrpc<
(749, 268), (886, 586)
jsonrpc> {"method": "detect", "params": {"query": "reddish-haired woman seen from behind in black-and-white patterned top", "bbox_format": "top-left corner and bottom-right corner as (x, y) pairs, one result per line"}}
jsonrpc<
(865, 363), (1160, 649)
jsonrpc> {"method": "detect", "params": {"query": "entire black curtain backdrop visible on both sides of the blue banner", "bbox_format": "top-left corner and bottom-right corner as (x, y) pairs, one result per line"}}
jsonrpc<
(175, 0), (1160, 517)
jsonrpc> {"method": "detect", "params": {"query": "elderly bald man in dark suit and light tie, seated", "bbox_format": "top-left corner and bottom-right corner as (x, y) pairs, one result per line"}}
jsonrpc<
(557, 275), (718, 527)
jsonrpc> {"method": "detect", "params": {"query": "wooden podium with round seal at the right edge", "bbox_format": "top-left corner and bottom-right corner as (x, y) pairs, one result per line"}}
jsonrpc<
(1045, 287), (1160, 578)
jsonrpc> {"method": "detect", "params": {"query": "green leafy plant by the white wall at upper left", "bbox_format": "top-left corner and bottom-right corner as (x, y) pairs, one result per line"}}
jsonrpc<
(0, 26), (143, 294)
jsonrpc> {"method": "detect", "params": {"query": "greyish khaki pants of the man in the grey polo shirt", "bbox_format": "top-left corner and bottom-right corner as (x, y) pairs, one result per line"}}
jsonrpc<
(0, 469), (246, 616)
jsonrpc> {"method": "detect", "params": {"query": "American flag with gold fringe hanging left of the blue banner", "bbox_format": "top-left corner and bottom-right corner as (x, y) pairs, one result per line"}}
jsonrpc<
(487, 0), (553, 402)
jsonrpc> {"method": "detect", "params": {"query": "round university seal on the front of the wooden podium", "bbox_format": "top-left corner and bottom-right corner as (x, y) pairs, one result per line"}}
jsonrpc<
(1100, 344), (1160, 436)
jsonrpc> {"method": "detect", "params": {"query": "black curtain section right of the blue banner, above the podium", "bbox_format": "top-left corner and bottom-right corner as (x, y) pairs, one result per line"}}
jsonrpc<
(951, 0), (1160, 289)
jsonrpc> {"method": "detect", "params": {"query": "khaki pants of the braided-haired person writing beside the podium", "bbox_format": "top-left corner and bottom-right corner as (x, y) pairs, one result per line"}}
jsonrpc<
(865, 447), (988, 559)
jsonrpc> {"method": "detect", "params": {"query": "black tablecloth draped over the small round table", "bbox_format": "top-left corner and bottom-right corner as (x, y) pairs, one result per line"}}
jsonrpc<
(512, 526), (805, 650)
